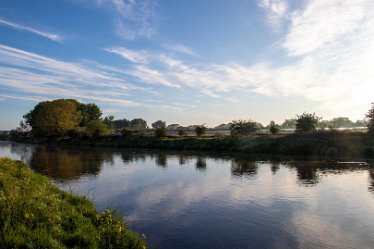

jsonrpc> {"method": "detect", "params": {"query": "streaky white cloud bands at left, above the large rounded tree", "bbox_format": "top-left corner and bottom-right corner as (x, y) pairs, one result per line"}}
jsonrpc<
(0, 45), (142, 106)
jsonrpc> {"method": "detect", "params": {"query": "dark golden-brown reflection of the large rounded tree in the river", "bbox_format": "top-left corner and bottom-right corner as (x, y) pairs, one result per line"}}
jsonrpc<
(30, 147), (113, 180)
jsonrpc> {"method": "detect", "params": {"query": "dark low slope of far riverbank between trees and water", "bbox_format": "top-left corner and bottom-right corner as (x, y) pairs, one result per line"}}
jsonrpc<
(10, 131), (374, 157)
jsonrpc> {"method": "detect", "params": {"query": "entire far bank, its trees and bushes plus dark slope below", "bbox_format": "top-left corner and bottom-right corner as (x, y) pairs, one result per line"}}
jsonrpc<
(5, 99), (374, 157)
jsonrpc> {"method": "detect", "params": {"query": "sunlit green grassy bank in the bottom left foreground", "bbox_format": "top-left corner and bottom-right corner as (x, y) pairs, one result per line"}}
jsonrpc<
(0, 158), (145, 248)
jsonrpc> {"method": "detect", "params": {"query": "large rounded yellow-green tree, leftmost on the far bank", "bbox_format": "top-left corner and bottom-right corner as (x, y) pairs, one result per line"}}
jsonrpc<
(24, 99), (82, 137)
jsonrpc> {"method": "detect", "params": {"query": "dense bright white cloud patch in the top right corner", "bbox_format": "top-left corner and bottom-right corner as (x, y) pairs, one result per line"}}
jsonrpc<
(283, 0), (373, 55)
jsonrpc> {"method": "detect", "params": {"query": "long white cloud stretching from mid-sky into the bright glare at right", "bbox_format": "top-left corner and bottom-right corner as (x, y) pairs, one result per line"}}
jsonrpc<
(104, 5), (374, 118)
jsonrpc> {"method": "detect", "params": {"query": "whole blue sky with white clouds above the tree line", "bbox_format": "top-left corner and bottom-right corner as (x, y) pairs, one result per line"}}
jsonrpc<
(0, 0), (374, 130)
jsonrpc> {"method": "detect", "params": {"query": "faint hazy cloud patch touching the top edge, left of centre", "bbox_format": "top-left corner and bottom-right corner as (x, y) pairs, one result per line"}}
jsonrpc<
(88, 0), (159, 40)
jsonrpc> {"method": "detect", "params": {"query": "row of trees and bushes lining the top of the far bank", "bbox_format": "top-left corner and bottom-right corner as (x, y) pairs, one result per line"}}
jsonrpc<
(19, 99), (374, 137)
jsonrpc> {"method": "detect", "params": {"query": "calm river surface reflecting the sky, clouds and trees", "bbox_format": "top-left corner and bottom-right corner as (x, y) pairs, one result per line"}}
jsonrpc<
(0, 142), (374, 248)
